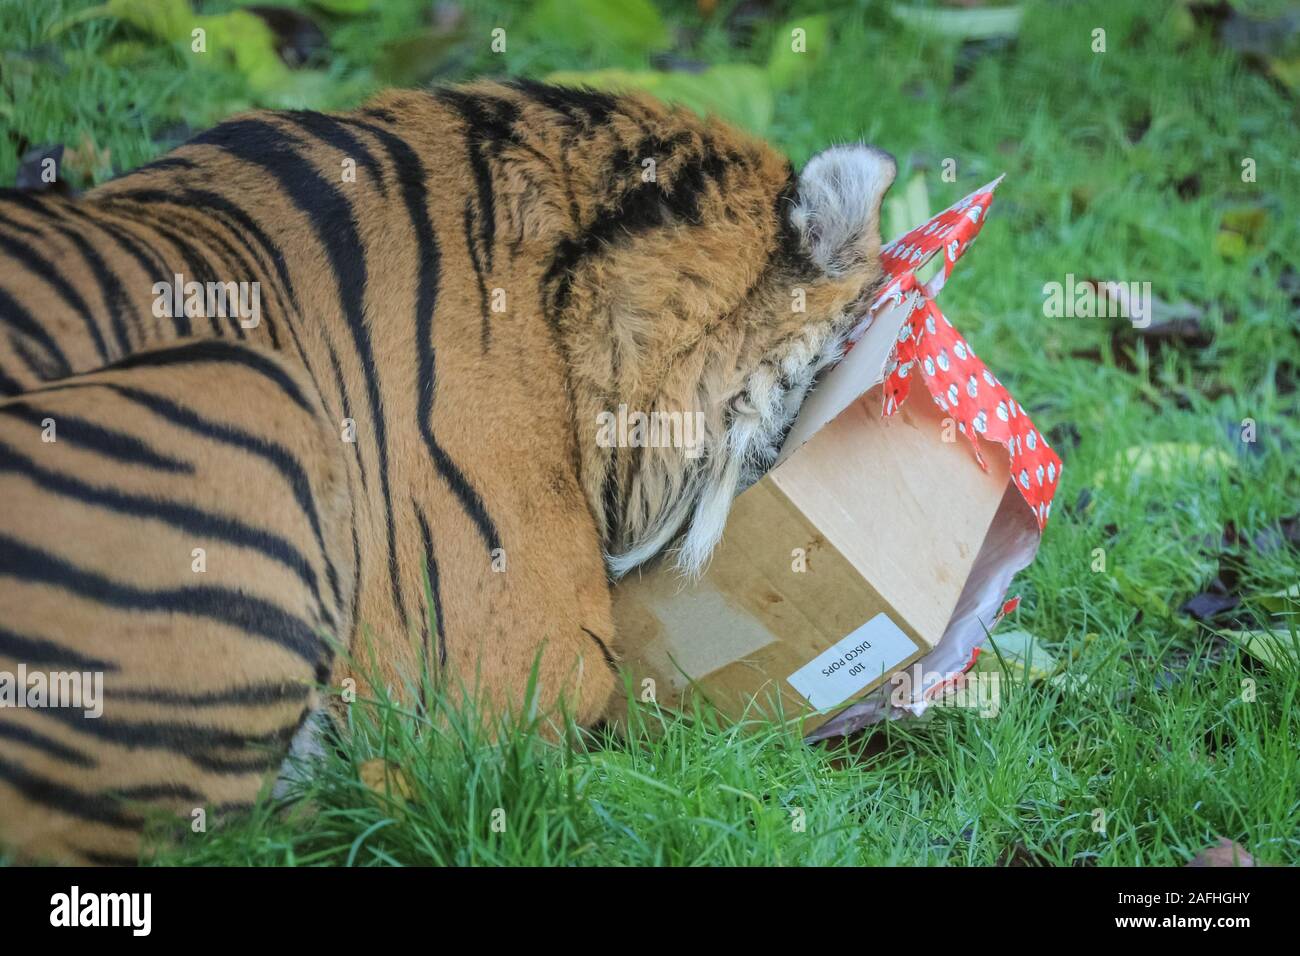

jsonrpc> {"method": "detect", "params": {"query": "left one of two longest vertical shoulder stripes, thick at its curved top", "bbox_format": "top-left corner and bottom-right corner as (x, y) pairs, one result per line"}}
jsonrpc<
(194, 120), (408, 629)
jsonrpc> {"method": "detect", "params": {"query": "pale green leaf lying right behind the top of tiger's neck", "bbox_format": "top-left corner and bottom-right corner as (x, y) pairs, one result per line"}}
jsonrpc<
(546, 64), (775, 133)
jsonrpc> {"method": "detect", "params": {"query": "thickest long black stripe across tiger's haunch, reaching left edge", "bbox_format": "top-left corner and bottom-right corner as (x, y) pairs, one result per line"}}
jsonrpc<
(0, 533), (330, 666)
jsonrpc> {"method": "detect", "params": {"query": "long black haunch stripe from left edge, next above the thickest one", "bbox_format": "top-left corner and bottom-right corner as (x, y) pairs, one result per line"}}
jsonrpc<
(0, 442), (325, 608)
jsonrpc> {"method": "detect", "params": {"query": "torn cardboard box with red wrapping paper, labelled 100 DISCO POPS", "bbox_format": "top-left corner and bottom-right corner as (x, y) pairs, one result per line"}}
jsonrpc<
(614, 175), (1060, 736)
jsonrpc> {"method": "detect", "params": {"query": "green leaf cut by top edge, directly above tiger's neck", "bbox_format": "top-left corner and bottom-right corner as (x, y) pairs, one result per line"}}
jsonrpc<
(525, 0), (672, 57)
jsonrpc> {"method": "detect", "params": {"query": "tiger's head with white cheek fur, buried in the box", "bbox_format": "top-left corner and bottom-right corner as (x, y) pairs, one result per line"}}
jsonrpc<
(553, 98), (896, 578)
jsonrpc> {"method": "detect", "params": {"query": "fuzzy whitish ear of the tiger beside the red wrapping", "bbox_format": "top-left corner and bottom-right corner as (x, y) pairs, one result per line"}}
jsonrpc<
(790, 143), (898, 278)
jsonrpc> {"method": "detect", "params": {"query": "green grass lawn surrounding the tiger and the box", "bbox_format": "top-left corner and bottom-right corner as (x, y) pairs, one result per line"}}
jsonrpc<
(0, 0), (1300, 865)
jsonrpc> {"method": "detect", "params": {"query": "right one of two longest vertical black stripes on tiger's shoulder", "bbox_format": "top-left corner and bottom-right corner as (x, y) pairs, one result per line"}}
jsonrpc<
(335, 115), (501, 551)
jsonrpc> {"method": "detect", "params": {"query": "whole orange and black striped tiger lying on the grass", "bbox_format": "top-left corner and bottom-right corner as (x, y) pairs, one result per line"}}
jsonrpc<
(0, 79), (896, 865)
